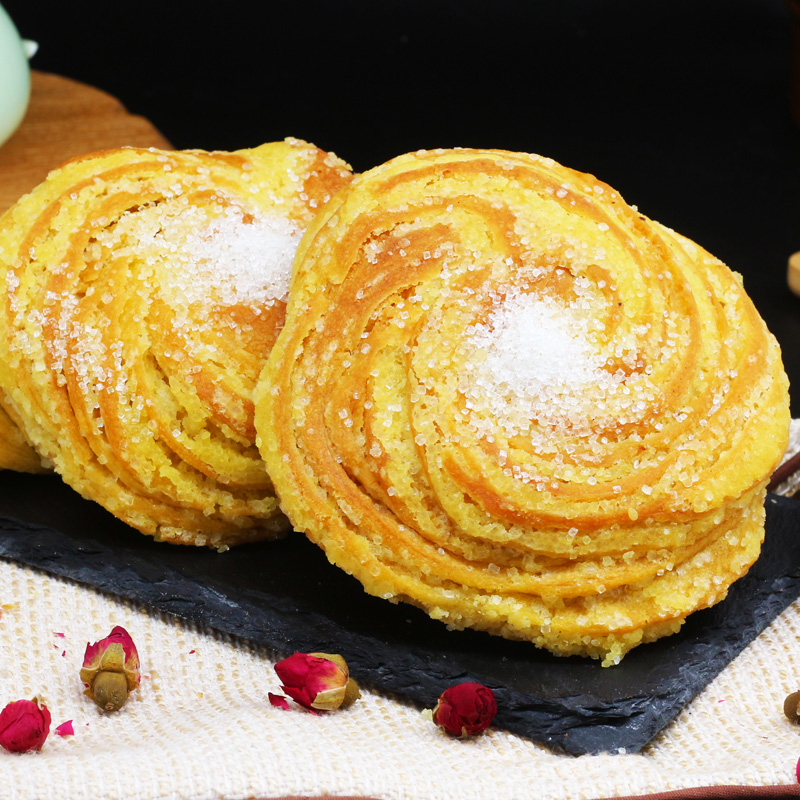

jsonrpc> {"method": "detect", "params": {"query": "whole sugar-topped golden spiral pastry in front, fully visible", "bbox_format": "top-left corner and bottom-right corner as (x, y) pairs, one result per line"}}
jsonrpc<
(256, 150), (789, 664)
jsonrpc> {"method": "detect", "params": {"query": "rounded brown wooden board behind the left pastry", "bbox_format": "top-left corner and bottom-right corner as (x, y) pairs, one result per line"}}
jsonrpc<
(0, 71), (170, 213)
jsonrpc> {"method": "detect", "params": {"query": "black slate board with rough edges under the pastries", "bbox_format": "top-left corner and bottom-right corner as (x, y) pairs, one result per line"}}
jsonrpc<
(0, 473), (800, 754)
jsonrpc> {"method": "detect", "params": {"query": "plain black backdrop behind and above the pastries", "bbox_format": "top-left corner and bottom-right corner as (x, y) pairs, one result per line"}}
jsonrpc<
(3, 0), (800, 416)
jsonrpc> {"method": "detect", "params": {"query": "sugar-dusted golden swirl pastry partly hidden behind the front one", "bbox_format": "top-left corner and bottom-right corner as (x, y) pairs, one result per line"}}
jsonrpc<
(0, 139), (351, 548)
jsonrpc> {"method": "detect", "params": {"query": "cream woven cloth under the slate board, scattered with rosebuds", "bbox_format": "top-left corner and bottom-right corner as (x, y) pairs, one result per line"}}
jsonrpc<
(0, 427), (800, 800)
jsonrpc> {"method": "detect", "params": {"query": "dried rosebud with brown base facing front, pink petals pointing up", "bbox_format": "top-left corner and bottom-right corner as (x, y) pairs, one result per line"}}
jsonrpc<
(81, 625), (141, 711)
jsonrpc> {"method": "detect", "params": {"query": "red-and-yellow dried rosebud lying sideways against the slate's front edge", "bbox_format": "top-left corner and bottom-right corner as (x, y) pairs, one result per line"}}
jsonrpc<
(275, 653), (360, 711)
